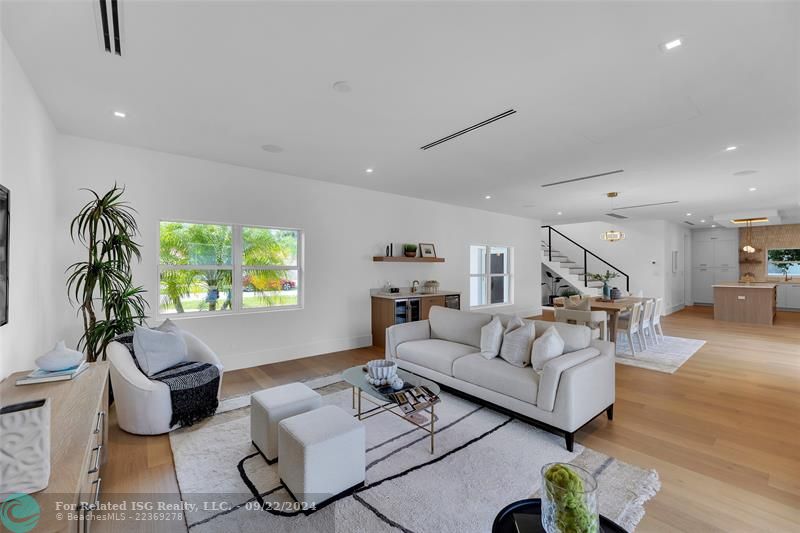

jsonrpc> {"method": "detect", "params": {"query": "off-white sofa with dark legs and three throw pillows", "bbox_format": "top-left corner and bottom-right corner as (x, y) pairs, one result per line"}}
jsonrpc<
(386, 307), (615, 451)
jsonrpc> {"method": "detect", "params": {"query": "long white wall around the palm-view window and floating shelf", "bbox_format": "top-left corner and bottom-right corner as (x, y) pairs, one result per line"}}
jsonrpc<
(53, 136), (541, 369)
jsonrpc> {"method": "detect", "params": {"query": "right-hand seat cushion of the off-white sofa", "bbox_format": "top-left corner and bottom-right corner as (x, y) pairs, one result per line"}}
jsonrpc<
(453, 354), (539, 405)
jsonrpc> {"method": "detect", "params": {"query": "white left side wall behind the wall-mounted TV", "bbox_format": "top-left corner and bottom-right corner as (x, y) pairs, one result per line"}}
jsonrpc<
(0, 37), (58, 378)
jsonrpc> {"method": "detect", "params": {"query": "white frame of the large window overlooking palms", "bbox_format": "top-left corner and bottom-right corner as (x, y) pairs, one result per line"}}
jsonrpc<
(156, 218), (305, 320)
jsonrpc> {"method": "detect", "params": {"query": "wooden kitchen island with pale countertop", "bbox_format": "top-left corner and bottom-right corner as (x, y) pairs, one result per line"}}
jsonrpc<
(713, 283), (777, 326)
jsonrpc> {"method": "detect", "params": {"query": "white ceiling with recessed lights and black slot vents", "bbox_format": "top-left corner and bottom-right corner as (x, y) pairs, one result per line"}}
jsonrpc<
(3, 0), (800, 225)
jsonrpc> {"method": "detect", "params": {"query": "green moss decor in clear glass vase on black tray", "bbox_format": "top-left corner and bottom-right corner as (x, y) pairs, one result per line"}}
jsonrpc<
(542, 463), (600, 533)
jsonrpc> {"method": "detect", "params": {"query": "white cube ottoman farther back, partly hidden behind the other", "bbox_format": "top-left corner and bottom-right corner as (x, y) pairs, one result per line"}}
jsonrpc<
(250, 383), (322, 464)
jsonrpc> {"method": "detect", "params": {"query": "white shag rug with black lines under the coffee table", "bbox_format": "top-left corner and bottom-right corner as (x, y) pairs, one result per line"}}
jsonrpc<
(170, 376), (660, 533)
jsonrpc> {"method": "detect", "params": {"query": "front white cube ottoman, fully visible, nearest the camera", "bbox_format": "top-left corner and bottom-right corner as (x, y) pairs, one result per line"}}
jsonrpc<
(278, 405), (366, 505)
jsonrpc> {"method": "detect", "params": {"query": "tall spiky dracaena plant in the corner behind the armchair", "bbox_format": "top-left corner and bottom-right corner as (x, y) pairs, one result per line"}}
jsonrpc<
(67, 183), (149, 362)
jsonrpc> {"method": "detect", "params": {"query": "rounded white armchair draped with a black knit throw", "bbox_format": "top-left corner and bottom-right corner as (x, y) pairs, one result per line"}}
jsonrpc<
(106, 331), (224, 435)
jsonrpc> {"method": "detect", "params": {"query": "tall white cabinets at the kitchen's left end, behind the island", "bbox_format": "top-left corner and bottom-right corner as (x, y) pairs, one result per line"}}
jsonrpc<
(692, 228), (739, 304)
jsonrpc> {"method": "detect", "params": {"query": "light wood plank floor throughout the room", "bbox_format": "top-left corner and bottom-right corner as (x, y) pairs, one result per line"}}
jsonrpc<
(98, 307), (800, 533)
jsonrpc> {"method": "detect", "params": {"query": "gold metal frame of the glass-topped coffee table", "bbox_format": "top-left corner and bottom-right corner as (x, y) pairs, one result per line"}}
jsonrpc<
(342, 365), (441, 454)
